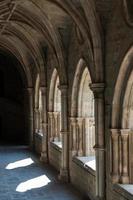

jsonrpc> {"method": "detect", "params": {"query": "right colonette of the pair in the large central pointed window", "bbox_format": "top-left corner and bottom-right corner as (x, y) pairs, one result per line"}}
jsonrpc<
(77, 118), (85, 156)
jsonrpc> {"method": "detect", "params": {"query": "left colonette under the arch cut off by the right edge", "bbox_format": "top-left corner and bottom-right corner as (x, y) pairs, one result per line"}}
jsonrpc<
(111, 129), (120, 183)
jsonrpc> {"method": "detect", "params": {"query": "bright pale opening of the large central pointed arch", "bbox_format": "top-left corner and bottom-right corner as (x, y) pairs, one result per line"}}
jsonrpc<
(78, 67), (95, 156)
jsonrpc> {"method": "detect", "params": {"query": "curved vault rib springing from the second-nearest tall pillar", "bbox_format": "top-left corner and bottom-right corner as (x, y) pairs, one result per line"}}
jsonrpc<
(15, 2), (67, 84)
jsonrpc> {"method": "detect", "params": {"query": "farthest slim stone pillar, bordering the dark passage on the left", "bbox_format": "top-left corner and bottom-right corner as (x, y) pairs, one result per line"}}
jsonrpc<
(27, 87), (34, 150)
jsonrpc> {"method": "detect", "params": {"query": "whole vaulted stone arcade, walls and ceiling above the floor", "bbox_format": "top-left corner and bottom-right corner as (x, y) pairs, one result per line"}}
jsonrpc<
(0, 0), (133, 200)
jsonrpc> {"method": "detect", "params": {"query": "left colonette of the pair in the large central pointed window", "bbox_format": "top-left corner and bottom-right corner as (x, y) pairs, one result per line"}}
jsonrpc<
(70, 117), (78, 157)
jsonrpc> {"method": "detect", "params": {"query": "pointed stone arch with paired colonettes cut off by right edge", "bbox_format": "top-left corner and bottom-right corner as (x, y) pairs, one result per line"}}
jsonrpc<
(111, 46), (133, 183)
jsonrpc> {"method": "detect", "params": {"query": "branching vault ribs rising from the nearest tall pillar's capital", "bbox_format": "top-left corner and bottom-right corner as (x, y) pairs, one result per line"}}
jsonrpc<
(47, 0), (104, 82)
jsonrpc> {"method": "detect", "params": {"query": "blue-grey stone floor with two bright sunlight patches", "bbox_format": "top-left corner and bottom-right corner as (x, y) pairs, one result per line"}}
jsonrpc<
(0, 146), (82, 200)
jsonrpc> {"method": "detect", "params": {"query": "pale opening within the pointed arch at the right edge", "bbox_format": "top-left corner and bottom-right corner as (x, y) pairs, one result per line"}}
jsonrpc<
(121, 70), (133, 183)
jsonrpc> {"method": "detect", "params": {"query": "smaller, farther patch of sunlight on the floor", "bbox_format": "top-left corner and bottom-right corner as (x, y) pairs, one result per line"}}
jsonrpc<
(6, 158), (34, 169)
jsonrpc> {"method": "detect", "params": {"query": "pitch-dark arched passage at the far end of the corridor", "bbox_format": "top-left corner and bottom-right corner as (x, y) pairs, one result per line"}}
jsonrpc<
(0, 52), (28, 145)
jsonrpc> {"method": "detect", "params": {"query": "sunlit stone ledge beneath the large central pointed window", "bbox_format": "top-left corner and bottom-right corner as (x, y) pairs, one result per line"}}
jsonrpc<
(72, 156), (96, 176)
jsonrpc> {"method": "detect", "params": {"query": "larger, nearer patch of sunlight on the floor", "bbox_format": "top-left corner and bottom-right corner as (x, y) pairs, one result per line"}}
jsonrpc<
(16, 175), (51, 192)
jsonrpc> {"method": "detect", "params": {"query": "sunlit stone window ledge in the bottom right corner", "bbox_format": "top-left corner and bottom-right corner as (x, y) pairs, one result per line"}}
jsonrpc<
(113, 184), (133, 200)
